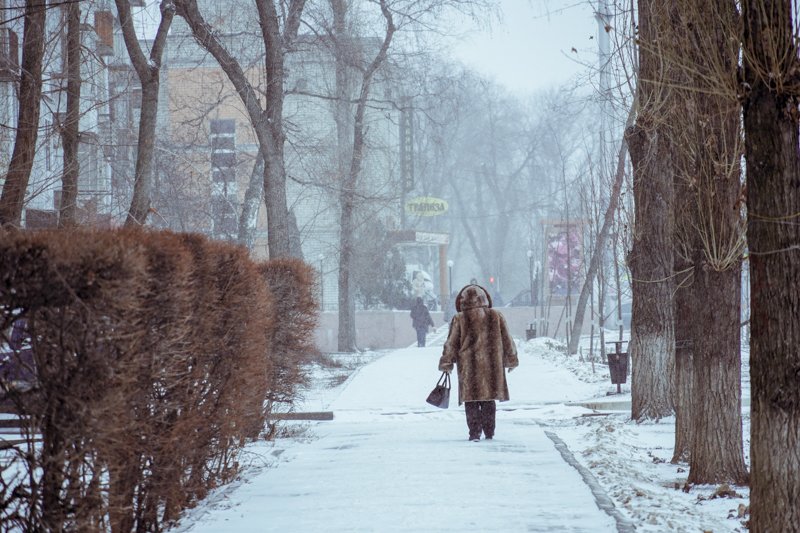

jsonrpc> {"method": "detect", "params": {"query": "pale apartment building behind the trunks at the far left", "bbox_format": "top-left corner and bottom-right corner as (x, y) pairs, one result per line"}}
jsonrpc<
(0, 0), (138, 228)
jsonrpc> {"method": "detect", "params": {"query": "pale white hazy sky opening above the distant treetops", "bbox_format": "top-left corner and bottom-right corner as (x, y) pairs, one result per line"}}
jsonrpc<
(453, 0), (597, 94)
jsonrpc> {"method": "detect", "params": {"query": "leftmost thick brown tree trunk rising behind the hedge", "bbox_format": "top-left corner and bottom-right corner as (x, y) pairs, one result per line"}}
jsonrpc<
(0, 0), (47, 226)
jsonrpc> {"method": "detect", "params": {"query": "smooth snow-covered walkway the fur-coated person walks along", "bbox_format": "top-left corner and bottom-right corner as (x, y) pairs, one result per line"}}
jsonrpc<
(179, 334), (619, 533)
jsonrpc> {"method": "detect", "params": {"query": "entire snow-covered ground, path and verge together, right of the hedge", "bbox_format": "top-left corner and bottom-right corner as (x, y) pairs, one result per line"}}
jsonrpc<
(175, 328), (749, 533)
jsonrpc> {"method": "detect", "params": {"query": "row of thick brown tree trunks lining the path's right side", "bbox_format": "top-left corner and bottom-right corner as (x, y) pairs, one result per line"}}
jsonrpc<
(608, 0), (800, 531)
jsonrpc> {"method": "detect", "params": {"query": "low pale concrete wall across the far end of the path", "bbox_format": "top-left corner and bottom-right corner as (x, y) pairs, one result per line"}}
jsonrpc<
(316, 306), (591, 352)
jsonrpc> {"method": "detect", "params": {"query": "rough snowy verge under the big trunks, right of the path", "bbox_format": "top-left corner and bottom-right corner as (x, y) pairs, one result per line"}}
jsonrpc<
(517, 339), (750, 533)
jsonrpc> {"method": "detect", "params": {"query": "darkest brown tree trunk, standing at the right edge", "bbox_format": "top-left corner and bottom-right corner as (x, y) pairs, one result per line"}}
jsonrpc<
(742, 0), (800, 533)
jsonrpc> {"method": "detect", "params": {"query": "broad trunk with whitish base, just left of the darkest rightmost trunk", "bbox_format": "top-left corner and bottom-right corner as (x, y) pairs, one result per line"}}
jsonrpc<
(682, 0), (747, 484)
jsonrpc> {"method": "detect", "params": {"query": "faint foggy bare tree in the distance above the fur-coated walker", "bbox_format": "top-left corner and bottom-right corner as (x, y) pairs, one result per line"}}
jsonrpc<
(434, 72), (560, 291)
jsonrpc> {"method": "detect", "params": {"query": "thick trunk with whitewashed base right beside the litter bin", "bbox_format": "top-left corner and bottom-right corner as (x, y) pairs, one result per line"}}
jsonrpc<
(626, 0), (675, 420)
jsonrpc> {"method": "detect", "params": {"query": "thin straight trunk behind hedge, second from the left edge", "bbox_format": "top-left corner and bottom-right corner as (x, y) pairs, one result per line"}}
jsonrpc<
(58, 3), (81, 227)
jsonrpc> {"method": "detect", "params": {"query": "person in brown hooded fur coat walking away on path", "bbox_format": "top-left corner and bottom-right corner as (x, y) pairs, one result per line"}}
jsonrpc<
(439, 284), (519, 441)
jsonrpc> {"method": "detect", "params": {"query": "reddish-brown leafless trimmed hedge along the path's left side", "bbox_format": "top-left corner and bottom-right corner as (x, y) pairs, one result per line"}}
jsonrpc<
(0, 230), (317, 532)
